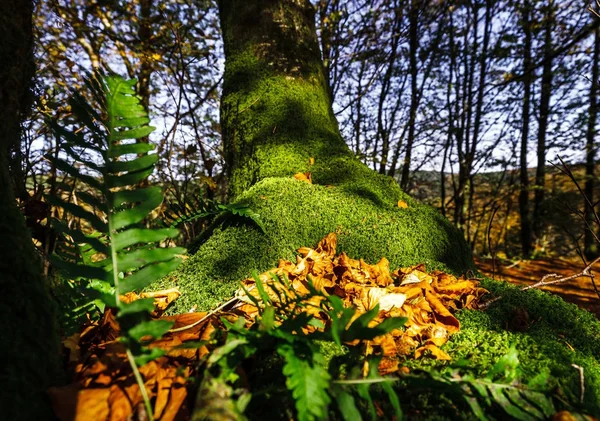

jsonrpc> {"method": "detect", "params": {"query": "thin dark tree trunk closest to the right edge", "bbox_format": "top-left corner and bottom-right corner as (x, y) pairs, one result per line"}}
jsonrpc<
(583, 29), (600, 260)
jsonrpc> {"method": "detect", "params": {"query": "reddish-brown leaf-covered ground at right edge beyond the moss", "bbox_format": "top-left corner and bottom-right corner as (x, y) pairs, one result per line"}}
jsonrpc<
(475, 258), (600, 318)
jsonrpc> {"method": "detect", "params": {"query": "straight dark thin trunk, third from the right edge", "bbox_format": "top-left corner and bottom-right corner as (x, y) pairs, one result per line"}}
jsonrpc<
(519, 1), (532, 258)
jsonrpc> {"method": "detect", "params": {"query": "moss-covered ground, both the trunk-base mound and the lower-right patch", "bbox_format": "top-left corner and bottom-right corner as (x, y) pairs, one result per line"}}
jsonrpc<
(153, 172), (600, 419)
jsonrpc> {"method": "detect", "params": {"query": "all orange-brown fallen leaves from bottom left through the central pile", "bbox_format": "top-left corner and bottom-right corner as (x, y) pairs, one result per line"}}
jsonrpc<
(49, 233), (488, 421)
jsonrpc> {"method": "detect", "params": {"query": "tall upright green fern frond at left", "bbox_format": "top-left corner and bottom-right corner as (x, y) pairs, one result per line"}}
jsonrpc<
(50, 70), (186, 414)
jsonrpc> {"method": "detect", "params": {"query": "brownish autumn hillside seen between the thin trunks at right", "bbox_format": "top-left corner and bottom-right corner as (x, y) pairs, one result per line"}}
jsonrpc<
(398, 164), (600, 257)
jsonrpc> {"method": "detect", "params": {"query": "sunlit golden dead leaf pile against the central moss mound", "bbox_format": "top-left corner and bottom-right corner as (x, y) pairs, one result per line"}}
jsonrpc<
(239, 233), (488, 374)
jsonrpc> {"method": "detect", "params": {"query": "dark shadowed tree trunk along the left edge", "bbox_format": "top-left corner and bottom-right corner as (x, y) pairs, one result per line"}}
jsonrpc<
(0, 0), (59, 420)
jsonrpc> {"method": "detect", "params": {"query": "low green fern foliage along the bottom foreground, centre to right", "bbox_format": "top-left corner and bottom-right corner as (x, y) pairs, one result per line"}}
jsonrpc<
(196, 270), (600, 421)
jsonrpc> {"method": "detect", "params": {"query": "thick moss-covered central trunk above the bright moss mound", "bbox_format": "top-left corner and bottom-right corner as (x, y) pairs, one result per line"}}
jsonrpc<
(219, 0), (351, 197)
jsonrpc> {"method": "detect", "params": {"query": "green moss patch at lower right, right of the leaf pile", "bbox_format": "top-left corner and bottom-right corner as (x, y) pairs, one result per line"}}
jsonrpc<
(400, 279), (600, 414)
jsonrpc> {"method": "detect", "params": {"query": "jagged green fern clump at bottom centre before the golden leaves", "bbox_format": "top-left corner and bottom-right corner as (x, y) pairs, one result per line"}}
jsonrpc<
(194, 277), (406, 421)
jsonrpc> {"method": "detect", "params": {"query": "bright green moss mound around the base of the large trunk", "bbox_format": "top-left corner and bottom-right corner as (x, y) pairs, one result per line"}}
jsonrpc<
(154, 177), (472, 313)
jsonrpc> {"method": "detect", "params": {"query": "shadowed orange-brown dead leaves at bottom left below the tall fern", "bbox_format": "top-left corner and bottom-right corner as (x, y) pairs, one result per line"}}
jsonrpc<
(49, 304), (223, 421)
